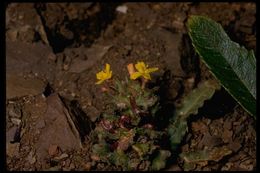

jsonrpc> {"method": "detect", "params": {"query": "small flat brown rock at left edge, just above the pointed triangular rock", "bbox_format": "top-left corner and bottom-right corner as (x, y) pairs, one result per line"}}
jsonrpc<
(6, 74), (46, 99)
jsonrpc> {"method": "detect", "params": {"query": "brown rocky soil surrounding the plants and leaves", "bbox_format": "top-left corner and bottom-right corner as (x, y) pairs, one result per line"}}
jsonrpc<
(6, 3), (256, 171)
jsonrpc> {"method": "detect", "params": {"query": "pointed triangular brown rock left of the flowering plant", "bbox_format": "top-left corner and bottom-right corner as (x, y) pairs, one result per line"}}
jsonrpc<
(36, 94), (82, 161)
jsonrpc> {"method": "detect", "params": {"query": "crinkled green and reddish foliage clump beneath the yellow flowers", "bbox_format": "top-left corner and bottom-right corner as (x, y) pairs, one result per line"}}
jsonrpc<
(92, 80), (171, 170)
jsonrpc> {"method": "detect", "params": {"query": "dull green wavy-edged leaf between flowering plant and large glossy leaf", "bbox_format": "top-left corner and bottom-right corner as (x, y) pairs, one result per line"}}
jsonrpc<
(168, 80), (220, 151)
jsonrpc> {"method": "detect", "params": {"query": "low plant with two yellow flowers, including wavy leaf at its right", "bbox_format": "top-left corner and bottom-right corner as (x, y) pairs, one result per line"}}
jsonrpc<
(89, 62), (219, 170)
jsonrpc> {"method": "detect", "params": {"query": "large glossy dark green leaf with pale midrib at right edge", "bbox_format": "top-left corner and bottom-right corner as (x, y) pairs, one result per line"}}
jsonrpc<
(188, 16), (256, 118)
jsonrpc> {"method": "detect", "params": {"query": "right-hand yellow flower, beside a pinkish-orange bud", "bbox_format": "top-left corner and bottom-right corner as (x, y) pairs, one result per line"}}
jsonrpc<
(130, 62), (158, 80)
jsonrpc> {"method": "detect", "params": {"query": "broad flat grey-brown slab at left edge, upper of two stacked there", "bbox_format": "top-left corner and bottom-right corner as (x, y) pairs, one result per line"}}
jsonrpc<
(6, 39), (56, 84)
